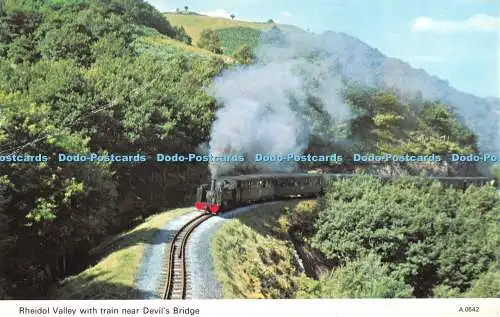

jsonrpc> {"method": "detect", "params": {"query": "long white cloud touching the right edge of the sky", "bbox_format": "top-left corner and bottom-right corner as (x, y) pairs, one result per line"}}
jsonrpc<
(412, 14), (500, 32)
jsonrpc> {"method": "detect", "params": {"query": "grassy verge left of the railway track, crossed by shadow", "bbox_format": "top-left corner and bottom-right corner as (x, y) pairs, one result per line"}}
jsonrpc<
(55, 207), (193, 299)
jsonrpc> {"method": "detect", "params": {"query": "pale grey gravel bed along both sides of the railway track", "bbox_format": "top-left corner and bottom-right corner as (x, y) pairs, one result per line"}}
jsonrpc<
(135, 201), (282, 299)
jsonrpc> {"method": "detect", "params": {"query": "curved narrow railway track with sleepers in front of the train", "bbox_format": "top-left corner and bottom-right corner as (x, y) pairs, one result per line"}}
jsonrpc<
(161, 213), (212, 299)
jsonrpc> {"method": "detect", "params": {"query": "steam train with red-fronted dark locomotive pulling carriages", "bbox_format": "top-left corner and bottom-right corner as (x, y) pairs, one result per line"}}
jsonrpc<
(194, 173), (493, 214)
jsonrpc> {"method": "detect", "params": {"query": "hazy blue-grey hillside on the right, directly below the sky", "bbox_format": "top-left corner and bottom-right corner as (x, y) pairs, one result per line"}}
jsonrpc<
(320, 32), (500, 151)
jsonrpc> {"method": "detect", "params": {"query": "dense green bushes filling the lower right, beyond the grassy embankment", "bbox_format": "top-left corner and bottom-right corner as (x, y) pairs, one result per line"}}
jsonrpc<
(312, 176), (500, 297)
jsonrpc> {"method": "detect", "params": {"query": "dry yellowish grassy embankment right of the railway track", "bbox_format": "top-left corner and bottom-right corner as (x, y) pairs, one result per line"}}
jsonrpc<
(211, 200), (316, 298)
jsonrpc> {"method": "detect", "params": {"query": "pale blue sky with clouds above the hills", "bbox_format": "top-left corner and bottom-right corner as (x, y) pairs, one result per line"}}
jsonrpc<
(148, 0), (500, 97)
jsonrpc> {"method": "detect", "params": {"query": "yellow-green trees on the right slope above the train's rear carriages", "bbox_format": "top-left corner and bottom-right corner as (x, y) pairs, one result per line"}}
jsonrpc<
(345, 88), (477, 155)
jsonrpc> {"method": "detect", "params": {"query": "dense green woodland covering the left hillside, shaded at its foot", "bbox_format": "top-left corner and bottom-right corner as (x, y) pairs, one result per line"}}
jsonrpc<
(0, 0), (224, 298)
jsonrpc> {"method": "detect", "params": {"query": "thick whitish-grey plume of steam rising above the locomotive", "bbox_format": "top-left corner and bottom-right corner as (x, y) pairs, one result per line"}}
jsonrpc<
(209, 29), (350, 177)
